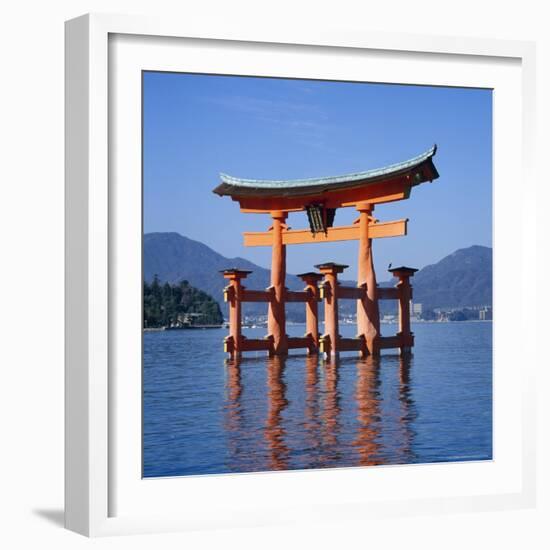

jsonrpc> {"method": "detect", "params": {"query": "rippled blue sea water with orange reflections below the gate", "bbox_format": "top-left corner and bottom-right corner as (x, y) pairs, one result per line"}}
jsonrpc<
(143, 322), (492, 477)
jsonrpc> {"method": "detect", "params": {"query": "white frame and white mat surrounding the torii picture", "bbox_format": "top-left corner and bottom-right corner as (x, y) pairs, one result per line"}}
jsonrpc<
(65, 15), (536, 536)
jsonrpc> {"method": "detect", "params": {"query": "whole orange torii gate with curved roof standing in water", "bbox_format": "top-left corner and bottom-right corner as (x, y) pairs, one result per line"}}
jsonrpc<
(214, 145), (439, 357)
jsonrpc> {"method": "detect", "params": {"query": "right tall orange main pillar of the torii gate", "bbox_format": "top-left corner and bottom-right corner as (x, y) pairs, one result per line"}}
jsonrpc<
(356, 202), (380, 355)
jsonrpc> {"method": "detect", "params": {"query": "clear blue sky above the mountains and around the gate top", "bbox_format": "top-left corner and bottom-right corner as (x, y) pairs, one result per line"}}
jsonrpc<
(144, 72), (492, 280)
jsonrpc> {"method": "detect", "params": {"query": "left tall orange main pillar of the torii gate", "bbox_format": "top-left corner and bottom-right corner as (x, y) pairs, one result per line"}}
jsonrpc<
(267, 211), (288, 355)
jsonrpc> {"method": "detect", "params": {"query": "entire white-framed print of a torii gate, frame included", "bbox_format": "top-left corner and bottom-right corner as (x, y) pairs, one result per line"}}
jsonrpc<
(66, 12), (535, 536)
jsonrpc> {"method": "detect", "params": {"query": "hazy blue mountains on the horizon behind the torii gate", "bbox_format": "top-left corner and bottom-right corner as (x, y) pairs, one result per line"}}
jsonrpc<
(143, 233), (493, 319)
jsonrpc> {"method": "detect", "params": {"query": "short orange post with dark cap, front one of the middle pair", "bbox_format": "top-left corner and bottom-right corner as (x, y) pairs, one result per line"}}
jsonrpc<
(315, 262), (348, 359)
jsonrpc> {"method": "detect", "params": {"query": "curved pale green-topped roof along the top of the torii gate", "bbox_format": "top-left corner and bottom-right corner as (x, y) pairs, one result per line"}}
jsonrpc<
(213, 145), (439, 201)
